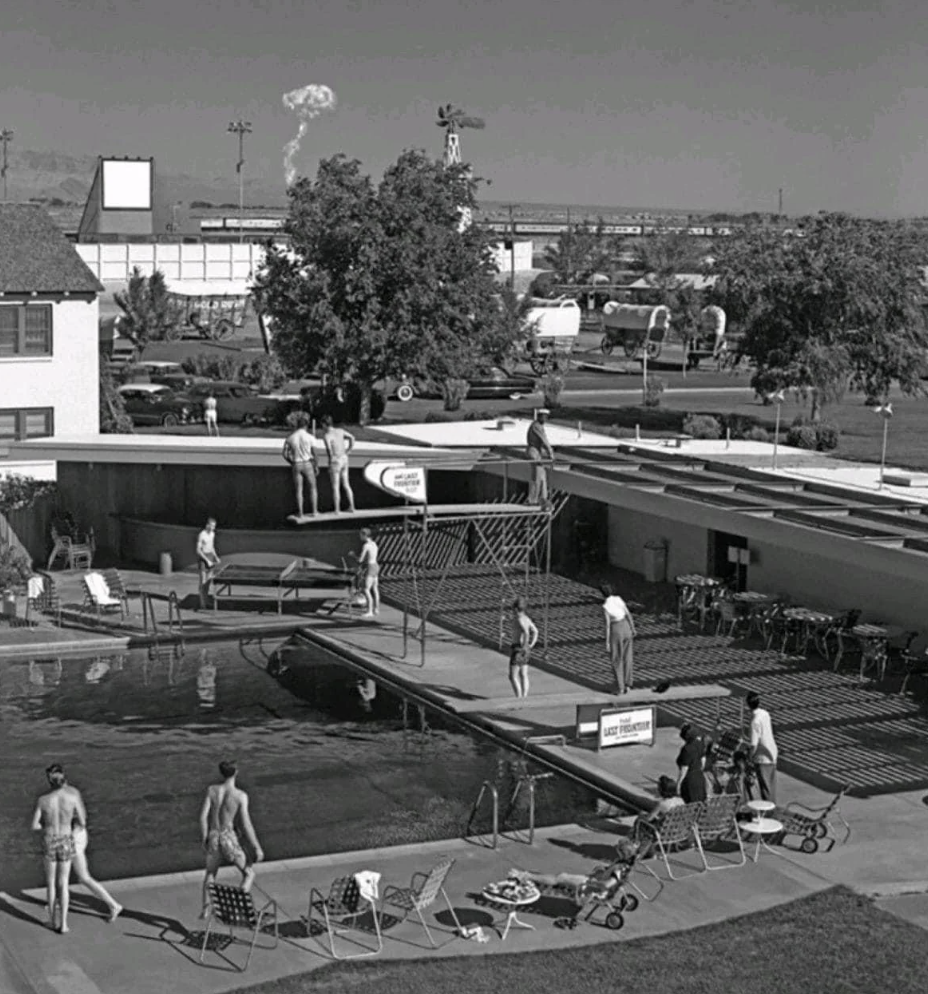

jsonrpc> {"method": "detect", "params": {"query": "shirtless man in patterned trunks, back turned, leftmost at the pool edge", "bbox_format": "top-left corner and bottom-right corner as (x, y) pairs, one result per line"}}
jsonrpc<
(32, 763), (85, 934)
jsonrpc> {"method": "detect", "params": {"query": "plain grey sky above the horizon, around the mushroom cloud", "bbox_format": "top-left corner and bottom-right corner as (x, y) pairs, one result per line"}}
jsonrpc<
(0, 0), (928, 216)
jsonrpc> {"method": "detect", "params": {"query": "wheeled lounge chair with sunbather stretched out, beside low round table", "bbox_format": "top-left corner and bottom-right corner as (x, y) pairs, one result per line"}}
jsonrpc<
(509, 853), (638, 930)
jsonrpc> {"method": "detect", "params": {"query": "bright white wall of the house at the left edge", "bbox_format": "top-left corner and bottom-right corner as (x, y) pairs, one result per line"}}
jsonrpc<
(0, 299), (100, 435)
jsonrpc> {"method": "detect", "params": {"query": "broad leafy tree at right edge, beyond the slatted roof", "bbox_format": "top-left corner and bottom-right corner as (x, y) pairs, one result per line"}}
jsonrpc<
(710, 213), (928, 421)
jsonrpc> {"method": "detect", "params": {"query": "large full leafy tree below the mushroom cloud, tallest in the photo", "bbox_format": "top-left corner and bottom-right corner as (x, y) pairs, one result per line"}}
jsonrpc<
(255, 151), (515, 420)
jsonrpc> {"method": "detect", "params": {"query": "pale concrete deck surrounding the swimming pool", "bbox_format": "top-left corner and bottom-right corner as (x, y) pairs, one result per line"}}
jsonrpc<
(0, 573), (928, 994)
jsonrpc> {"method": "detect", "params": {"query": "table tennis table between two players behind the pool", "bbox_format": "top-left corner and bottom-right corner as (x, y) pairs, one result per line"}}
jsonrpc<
(207, 559), (357, 614)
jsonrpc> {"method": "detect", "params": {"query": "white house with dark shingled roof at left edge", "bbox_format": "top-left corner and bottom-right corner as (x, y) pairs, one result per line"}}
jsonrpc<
(0, 204), (103, 446)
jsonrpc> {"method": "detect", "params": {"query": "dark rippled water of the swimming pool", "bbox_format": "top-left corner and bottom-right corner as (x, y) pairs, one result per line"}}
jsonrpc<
(0, 640), (595, 889)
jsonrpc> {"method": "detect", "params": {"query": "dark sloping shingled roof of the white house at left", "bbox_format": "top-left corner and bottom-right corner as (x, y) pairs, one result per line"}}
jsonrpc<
(0, 204), (103, 294)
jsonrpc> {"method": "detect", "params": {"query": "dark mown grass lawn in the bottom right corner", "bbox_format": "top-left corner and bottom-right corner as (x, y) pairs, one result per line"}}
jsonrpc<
(237, 888), (928, 994)
